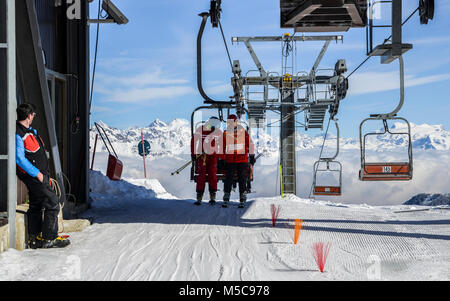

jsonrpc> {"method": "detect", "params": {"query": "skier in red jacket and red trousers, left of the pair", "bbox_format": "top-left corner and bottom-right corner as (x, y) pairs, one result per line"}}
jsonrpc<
(191, 117), (222, 205)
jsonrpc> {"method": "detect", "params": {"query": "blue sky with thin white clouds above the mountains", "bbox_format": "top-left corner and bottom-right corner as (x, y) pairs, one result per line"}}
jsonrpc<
(91, 0), (450, 137)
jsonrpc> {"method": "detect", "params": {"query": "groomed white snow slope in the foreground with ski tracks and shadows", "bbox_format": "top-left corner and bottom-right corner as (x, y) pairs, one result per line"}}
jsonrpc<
(0, 172), (450, 280)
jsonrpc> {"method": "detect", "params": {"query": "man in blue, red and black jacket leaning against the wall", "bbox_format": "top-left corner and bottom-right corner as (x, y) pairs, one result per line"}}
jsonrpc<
(16, 103), (70, 249)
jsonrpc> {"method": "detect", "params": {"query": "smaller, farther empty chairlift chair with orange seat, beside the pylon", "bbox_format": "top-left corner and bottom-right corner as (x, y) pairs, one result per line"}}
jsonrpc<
(313, 118), (342, 196)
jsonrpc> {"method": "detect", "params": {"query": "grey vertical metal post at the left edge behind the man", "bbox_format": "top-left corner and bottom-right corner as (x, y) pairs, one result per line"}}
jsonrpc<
(0, 0), (17, 248)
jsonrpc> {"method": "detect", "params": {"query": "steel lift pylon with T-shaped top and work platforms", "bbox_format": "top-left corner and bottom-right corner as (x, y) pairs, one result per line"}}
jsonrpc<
(232, 34), (348, 194)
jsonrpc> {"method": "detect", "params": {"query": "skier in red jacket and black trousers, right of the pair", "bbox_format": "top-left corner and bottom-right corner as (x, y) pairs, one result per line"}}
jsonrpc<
(223, 115), (255, 207)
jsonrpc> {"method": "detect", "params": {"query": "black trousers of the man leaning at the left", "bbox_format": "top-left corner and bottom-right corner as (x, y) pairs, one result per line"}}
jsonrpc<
(22, 175), (60, 240)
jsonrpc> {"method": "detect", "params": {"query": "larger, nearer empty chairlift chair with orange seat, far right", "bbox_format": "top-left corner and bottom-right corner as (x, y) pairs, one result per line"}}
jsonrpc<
(359, 56), (413, 181)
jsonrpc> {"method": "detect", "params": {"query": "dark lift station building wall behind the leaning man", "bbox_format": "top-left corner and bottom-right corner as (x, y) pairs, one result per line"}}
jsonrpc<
(0, 0), (89, 217)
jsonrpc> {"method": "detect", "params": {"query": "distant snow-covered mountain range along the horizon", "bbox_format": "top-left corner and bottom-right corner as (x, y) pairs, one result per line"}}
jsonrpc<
(90, 119), (450, 156)
